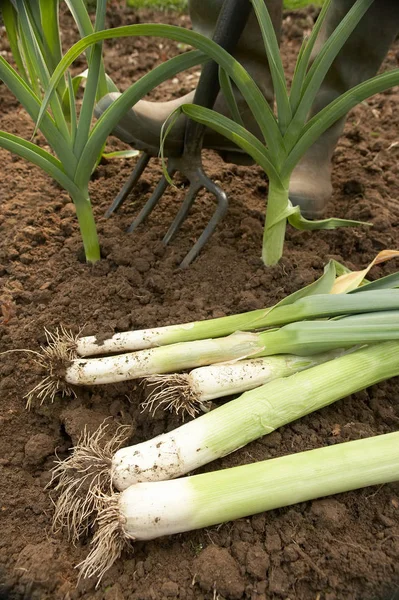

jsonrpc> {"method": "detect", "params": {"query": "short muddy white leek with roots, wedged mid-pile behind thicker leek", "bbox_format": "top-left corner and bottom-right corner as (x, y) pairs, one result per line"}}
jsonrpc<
(142, 351), (344, 417)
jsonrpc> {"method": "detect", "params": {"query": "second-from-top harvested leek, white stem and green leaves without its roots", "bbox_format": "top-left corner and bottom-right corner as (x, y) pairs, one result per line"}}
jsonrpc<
(65, 312), (399, 385)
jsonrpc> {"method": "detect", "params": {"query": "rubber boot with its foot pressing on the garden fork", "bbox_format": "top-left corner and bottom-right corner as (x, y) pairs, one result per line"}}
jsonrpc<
(96, 0), (282, 164)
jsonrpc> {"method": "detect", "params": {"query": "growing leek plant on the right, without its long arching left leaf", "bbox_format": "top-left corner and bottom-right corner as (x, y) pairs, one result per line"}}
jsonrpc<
(181, 0), (399, 265)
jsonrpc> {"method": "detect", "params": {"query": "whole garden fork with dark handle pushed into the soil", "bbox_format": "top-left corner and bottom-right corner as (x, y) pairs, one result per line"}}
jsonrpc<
(105, 0), (251, 267)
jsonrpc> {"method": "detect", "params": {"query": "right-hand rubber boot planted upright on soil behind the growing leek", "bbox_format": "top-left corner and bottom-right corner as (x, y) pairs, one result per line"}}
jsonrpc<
(290, 0), (399, 218)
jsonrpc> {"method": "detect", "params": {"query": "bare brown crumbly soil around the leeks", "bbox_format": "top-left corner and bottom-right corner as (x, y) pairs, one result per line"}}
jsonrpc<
(0, 4), (399, 600)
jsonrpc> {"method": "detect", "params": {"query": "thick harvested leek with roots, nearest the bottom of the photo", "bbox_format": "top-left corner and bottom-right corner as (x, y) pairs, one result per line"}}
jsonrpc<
(79, 433), (399, 579)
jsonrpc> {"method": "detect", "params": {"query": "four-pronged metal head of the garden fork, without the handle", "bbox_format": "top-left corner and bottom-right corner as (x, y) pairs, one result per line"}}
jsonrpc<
(105, 152), (228, 268)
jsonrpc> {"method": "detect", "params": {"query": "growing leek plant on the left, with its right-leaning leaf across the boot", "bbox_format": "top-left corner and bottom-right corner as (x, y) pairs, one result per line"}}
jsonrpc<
(0, 0), (209, 263)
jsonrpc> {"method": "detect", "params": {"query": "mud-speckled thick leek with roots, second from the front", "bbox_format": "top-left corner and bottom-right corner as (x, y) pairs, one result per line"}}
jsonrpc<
(54, 342), (399, 537)
